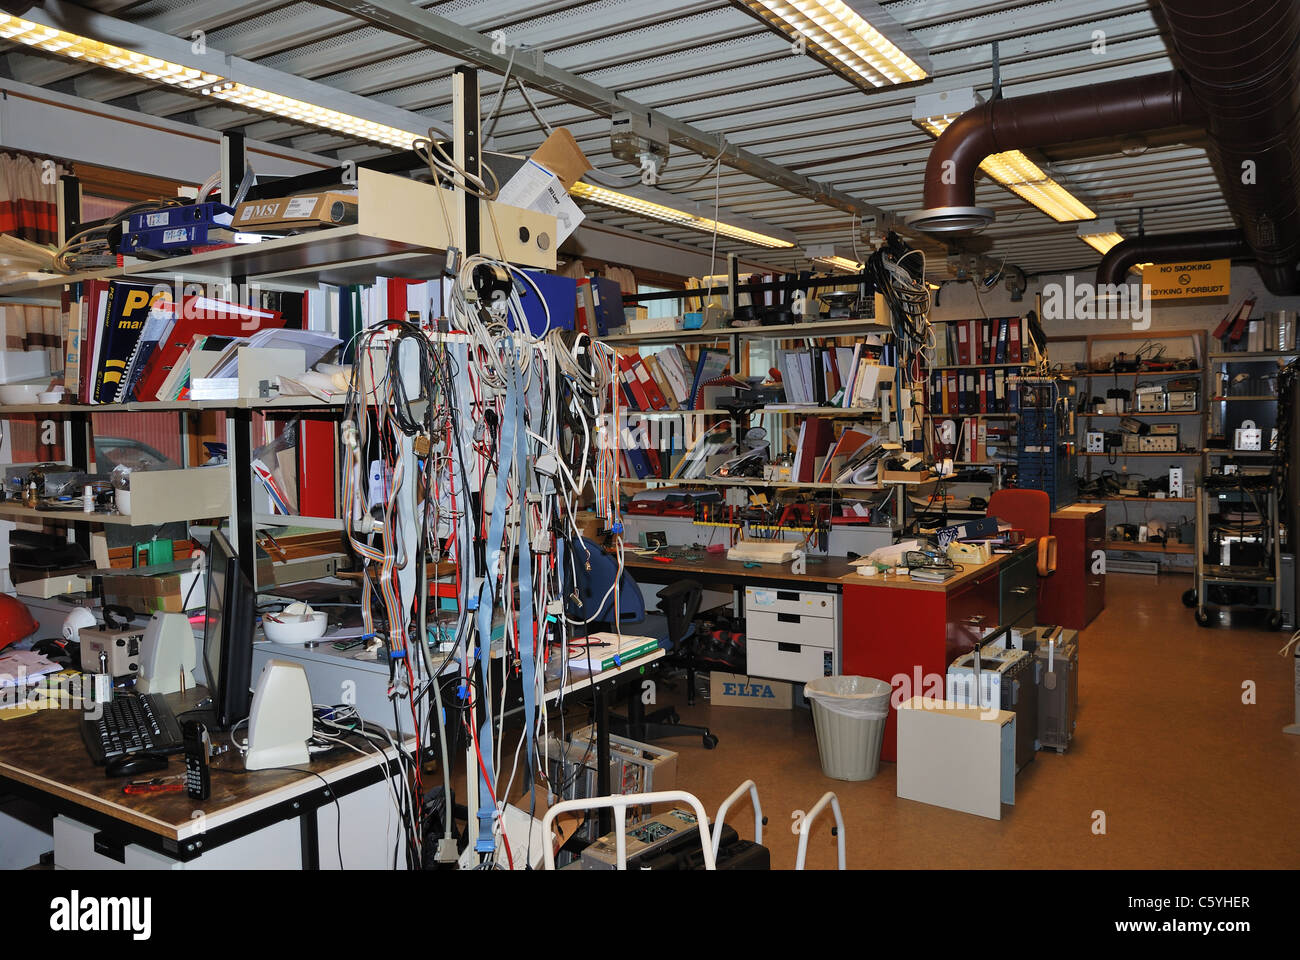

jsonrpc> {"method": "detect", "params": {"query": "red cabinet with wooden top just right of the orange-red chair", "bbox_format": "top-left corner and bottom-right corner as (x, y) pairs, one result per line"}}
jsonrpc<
(1039, 503), (1106, 630)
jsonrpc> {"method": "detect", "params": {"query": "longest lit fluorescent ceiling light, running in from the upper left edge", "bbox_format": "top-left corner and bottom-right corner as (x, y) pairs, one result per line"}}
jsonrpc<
(0, 13), (428, 150)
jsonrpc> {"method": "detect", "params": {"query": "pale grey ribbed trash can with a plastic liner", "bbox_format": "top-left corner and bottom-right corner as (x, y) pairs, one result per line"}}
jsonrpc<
(803, 676), (891, 780)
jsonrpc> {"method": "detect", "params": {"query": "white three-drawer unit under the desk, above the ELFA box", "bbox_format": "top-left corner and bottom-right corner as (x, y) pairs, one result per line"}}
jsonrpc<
(745, 587), (840, 683)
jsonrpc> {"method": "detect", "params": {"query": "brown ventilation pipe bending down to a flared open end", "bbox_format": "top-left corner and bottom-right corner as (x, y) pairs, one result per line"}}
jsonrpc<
(907, 73), (1204, 234)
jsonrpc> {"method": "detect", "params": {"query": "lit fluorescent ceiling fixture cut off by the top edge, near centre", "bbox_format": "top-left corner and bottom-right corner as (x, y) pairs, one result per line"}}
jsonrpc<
(732, 0), (930, 88)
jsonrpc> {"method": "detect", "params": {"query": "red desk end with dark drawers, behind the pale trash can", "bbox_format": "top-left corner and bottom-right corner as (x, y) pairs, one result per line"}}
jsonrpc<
(841, 541), (1037, 761)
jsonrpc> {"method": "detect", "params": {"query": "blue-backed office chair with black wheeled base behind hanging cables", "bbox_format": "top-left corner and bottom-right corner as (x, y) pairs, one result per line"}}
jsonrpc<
(564, 537), (718, 749)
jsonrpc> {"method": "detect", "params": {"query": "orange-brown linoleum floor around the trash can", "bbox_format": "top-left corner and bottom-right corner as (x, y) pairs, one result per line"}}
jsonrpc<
(644, 575), (1300, 869)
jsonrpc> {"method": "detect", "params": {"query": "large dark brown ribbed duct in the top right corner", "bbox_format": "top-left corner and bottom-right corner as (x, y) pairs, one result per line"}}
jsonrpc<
(1152, 0), (1300, 295)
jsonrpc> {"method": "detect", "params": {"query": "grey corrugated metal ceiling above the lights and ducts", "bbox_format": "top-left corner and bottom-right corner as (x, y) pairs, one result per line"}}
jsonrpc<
(5, 0), (1231, 273)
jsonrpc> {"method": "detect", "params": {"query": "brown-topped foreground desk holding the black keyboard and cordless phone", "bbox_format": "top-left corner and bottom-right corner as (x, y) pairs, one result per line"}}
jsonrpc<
(0, 687), (402, 869)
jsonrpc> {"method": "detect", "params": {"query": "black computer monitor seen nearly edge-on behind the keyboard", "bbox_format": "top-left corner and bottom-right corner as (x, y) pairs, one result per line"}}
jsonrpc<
(203, 531), (255, 730)
